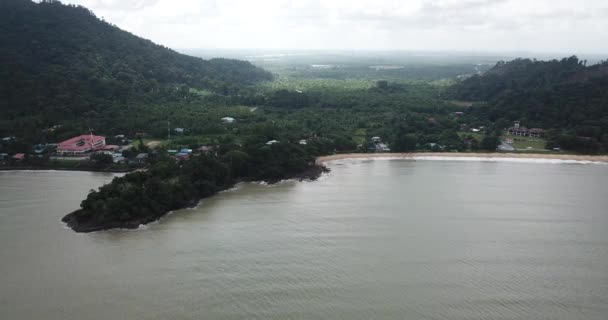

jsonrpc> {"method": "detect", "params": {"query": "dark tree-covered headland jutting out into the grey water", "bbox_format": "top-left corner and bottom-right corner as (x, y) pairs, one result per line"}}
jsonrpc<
(63, 143), (323, 232)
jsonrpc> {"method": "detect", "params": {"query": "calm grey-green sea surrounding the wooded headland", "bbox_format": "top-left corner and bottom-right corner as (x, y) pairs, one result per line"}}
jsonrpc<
(0, 160), (608, 320)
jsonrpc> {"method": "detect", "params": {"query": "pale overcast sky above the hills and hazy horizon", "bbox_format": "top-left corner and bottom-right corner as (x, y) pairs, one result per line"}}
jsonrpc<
(62, 0), (608, 54)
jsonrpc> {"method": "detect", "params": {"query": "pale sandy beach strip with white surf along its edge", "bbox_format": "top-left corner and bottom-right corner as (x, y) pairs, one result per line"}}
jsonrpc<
(317, 152), (608, 164)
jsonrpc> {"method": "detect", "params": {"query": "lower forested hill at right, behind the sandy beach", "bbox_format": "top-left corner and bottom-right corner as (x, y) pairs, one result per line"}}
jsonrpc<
(451, 57), (608, 152)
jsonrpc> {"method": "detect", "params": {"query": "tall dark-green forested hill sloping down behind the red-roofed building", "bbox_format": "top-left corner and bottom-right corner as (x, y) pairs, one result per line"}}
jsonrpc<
(0, 0), (272, 117)
